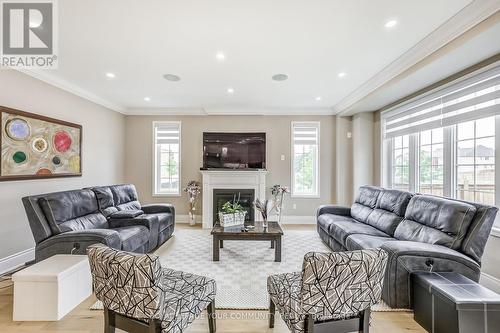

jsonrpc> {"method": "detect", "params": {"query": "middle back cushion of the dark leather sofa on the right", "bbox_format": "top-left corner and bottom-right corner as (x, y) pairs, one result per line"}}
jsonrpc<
(366, 189), (412, 236)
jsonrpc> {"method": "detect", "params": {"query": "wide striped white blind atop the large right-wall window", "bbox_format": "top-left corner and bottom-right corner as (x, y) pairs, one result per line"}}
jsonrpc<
(384, 64), (500, 138)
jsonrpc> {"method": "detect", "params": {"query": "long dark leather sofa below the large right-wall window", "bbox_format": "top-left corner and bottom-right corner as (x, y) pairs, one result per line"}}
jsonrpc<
(317, 186), (498, 308)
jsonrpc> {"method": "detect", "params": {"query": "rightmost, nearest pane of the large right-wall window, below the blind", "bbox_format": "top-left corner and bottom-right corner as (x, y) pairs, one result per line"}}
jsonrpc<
(455, 117), (495, 205)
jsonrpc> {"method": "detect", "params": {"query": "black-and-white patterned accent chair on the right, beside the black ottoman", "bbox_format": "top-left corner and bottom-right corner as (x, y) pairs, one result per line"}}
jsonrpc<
(267, 249), (387, 333)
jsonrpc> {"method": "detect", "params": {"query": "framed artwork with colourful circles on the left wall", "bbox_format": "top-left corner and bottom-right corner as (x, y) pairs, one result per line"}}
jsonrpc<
(0, 106), (82, 181)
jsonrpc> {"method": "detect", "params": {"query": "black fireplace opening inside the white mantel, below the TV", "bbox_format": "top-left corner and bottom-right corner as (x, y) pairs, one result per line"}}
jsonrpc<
(212, 189), (255, 224)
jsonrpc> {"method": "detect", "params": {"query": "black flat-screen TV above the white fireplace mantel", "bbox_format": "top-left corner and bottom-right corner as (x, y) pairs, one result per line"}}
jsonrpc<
(203, 132), (266, 169)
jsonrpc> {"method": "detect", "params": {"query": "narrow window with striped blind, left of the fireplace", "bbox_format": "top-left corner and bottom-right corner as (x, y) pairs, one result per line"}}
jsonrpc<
(153, 121), (181, 195)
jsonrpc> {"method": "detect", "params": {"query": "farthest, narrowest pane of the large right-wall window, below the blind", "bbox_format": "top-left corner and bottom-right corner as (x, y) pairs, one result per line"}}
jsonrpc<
(392, 135), (410, 191)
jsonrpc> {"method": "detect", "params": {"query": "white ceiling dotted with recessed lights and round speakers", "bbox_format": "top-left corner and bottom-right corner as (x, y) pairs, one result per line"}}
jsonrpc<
(21, 0), (500, 114)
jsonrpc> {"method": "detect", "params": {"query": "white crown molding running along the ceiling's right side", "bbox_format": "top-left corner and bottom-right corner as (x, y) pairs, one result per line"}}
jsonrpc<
(333, 0), (500, 116)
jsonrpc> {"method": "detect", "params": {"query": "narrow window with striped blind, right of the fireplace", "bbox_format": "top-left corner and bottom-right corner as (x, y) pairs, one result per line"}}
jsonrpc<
(292, 122), (319, 197)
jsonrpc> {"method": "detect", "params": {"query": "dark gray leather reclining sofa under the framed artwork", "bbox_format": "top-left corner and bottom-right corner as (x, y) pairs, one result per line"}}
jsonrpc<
(22, 184), (175, 262)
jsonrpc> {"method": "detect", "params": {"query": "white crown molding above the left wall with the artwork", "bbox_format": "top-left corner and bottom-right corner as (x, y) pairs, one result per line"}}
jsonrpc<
(16, 68), (126, 114)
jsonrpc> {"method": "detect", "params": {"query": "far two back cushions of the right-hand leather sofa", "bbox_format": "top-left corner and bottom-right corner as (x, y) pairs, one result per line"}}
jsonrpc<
(351, 186), (412, 236)
